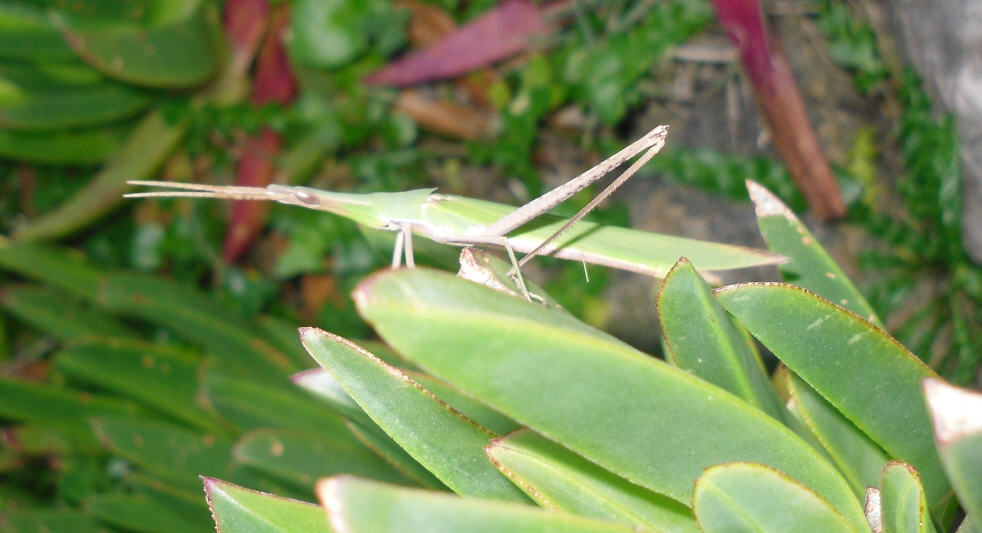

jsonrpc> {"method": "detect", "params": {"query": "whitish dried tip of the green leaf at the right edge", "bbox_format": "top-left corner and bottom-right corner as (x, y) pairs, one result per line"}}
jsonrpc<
(921, 378), (982, 446)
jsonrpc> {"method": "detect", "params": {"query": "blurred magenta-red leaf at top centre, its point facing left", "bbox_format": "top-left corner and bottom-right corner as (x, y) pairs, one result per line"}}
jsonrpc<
(365, 0), (549, 86)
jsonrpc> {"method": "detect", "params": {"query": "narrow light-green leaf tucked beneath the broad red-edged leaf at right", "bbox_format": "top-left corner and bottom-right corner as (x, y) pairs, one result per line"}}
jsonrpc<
(785, 366), (890, 497)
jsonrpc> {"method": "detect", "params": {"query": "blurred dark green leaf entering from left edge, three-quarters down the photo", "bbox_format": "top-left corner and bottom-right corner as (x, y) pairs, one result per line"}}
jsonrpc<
(0, 378), (140, 441)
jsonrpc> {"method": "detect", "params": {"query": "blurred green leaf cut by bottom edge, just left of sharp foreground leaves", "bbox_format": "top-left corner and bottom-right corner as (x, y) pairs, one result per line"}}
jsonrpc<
(85, 492), (214, 533)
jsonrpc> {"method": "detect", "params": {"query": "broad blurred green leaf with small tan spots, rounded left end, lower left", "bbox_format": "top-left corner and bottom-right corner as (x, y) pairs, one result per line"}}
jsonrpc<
(55, 340), (220, 430)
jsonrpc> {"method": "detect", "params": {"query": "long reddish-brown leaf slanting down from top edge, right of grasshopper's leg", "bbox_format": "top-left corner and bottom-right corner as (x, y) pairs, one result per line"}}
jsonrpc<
(713, 0), (846, 220)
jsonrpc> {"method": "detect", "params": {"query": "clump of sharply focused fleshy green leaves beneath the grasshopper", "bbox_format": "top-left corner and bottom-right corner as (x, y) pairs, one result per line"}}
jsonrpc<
(198, 183), (982, 532)
